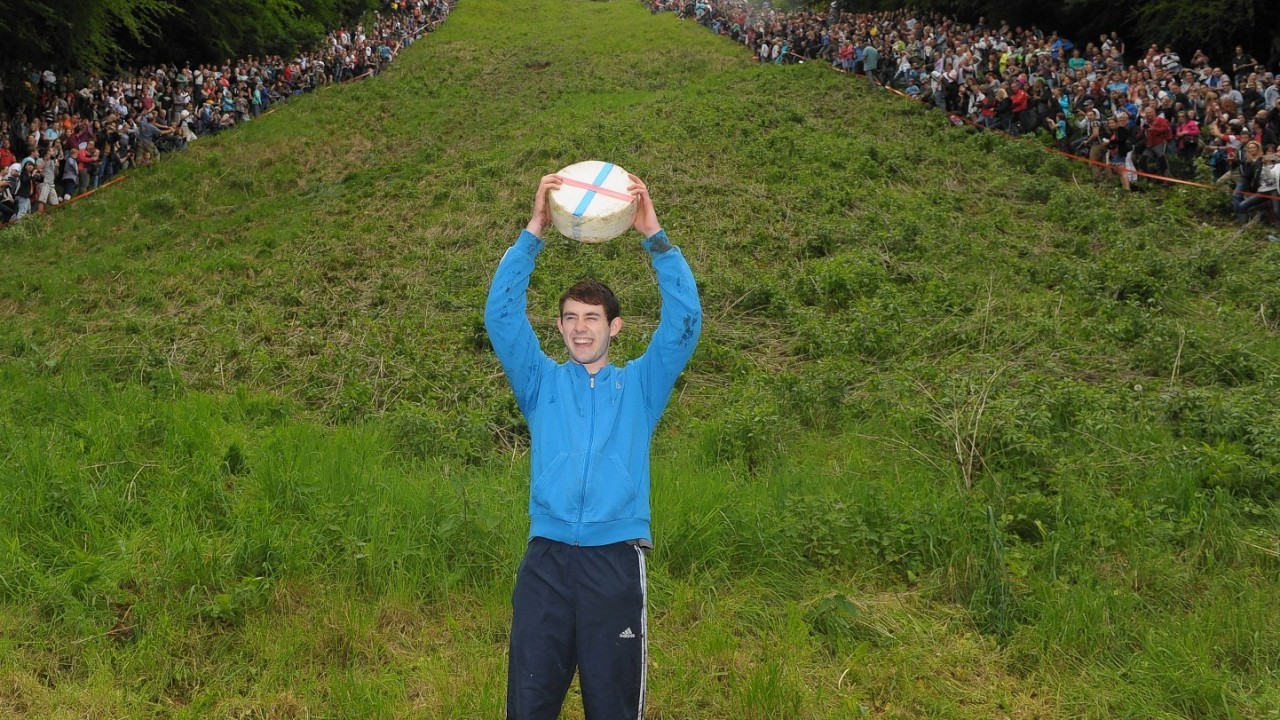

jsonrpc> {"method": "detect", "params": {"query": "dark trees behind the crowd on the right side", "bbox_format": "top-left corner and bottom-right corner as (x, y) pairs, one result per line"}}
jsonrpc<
(822, 0), (1280, 69)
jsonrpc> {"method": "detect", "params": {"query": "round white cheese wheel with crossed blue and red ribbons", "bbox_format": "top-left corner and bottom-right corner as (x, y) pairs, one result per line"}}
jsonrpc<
(548, 160), (637, 242)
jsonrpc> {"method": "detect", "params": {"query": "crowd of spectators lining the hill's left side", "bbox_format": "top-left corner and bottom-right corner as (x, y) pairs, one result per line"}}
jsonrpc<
(0, 0), (454, 224)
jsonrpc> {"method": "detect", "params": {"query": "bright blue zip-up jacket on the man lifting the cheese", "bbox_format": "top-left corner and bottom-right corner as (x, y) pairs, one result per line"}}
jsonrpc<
(485, 231), (703, 546)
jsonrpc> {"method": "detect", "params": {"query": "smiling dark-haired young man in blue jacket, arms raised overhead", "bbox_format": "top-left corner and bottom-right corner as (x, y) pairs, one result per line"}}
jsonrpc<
(485, 174), (701, 720)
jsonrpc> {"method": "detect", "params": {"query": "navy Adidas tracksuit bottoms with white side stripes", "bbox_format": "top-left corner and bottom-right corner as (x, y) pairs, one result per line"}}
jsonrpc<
(507, 538), (648, 720)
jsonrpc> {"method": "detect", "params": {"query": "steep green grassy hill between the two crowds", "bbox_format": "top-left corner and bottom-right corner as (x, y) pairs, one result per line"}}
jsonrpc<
(0, 0), (1280, 719)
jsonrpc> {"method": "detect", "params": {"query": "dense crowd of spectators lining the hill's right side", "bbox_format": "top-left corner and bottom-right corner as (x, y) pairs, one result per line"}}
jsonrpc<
(645, 0), (1280, 223)
